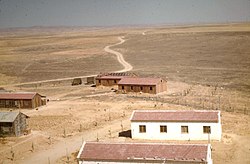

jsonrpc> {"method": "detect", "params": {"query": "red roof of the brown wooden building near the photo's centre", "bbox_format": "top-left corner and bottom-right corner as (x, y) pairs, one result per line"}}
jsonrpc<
(118, 77), (162, 85)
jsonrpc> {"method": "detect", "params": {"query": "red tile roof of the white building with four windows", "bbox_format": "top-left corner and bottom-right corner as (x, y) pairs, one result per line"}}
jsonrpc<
(131, 110), (220, 122)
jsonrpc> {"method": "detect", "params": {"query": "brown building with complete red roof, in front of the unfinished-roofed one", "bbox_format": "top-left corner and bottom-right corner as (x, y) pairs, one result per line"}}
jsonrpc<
(118, 77), (167, 94)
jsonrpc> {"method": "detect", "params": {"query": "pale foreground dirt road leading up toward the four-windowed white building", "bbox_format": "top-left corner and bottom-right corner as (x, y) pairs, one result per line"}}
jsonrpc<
(18, 118), (130, 164)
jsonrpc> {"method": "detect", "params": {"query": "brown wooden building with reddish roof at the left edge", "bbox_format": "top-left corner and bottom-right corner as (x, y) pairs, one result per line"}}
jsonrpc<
(0, 92), (46, 108)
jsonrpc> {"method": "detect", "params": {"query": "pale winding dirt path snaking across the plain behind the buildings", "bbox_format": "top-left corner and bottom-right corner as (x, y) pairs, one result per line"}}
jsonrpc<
(104, 37), (133, 72)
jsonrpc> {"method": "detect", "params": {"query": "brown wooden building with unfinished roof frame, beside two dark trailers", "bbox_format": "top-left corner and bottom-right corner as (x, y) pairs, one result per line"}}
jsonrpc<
(96, 72), (136, 86)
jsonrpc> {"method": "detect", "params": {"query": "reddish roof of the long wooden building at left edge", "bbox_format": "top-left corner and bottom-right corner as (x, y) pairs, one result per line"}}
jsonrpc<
(0, 92), (37, 100)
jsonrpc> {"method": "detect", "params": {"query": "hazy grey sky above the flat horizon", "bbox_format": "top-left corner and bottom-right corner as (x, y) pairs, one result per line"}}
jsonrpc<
(0, 0), (250, 28)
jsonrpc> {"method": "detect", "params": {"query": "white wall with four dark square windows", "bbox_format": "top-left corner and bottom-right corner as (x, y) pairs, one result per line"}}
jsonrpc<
(131, 122), (222, 141)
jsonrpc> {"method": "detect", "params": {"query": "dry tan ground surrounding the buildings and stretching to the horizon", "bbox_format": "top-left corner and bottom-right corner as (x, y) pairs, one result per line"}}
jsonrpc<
(0, 23), (250, 164)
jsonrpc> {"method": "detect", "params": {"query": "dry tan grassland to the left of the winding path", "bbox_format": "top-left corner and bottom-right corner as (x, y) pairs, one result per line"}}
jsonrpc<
(0, 28), (127, 84)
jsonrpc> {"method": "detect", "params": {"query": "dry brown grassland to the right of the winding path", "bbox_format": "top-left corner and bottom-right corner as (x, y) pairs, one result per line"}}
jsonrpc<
(117, 28), (250, 93)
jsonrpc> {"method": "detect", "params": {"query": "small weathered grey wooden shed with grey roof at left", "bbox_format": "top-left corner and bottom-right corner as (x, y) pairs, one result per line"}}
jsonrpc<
(0, 112), (29, 136)
